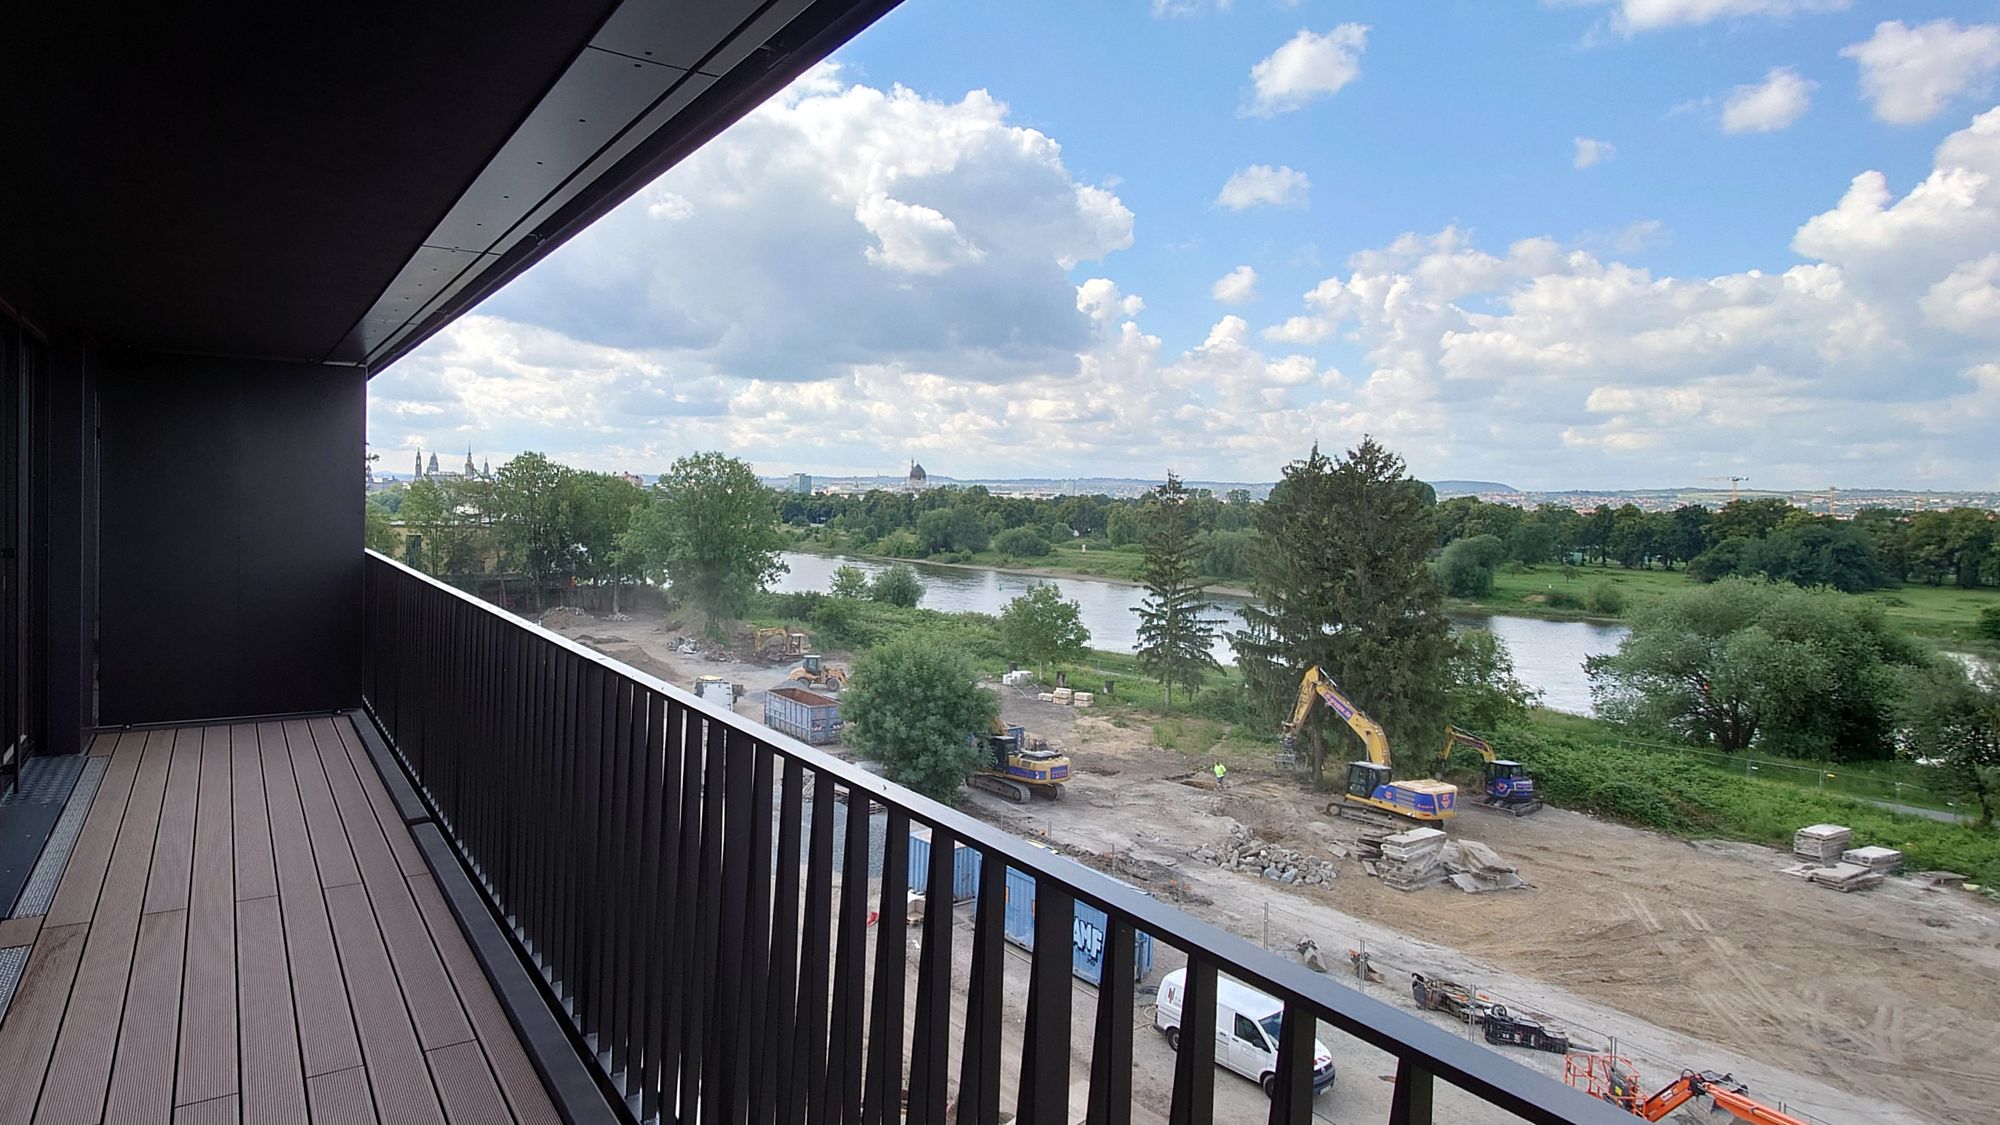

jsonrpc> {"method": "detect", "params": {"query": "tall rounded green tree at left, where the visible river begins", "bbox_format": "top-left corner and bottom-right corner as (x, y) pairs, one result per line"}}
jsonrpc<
(622, 452), (784, 621)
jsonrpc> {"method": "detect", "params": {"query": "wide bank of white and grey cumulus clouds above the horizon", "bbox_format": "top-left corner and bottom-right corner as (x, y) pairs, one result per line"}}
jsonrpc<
(370, 72), (2000, 486)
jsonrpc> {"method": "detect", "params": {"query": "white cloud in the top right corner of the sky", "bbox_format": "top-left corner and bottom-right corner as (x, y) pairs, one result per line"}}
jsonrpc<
(1840, 20), (2000, 124)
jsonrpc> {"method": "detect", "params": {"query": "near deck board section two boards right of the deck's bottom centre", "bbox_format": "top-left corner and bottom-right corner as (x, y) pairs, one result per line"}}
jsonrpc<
(326, 885), (444, 1123)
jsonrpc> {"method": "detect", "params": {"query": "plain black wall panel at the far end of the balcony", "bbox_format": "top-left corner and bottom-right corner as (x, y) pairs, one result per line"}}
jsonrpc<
(98, 350), (366, 725)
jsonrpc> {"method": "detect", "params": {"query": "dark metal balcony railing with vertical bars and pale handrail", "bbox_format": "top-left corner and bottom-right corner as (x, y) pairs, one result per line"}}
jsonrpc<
(364, 552), (1628, 1125)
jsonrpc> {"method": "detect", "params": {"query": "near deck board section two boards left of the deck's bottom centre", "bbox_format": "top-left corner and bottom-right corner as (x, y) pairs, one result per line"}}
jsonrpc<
(90, 911), (188, 1125)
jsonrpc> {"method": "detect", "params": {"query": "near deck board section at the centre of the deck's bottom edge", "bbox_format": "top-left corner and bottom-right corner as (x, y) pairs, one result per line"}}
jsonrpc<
(236, 895), (306, 1125)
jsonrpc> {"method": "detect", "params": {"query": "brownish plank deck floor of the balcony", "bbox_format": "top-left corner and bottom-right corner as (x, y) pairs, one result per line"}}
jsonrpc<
(0, 719), (558, 1125)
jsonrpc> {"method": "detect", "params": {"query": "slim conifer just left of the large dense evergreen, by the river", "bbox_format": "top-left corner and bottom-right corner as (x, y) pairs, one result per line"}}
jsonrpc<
(1134, 472), (1216, 709)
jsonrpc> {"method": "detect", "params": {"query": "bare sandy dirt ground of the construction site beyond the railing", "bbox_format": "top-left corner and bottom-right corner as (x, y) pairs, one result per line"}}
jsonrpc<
(974, 695), (2000, 1125)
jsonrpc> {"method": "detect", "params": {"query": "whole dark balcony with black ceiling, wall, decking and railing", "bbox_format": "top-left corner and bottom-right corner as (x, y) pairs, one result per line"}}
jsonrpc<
(0, 0), (1626, 1125)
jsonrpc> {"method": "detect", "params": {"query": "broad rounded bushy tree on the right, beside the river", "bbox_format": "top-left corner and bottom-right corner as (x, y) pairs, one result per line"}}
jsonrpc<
(1584, 579), (1926, 761)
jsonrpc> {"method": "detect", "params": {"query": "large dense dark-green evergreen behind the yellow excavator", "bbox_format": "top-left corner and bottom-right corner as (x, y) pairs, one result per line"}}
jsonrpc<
(1236, 438), (1452, 779)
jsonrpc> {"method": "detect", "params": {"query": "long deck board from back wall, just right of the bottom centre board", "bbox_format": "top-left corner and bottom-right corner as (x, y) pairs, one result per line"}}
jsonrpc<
(258, 723), (362, 1077)
